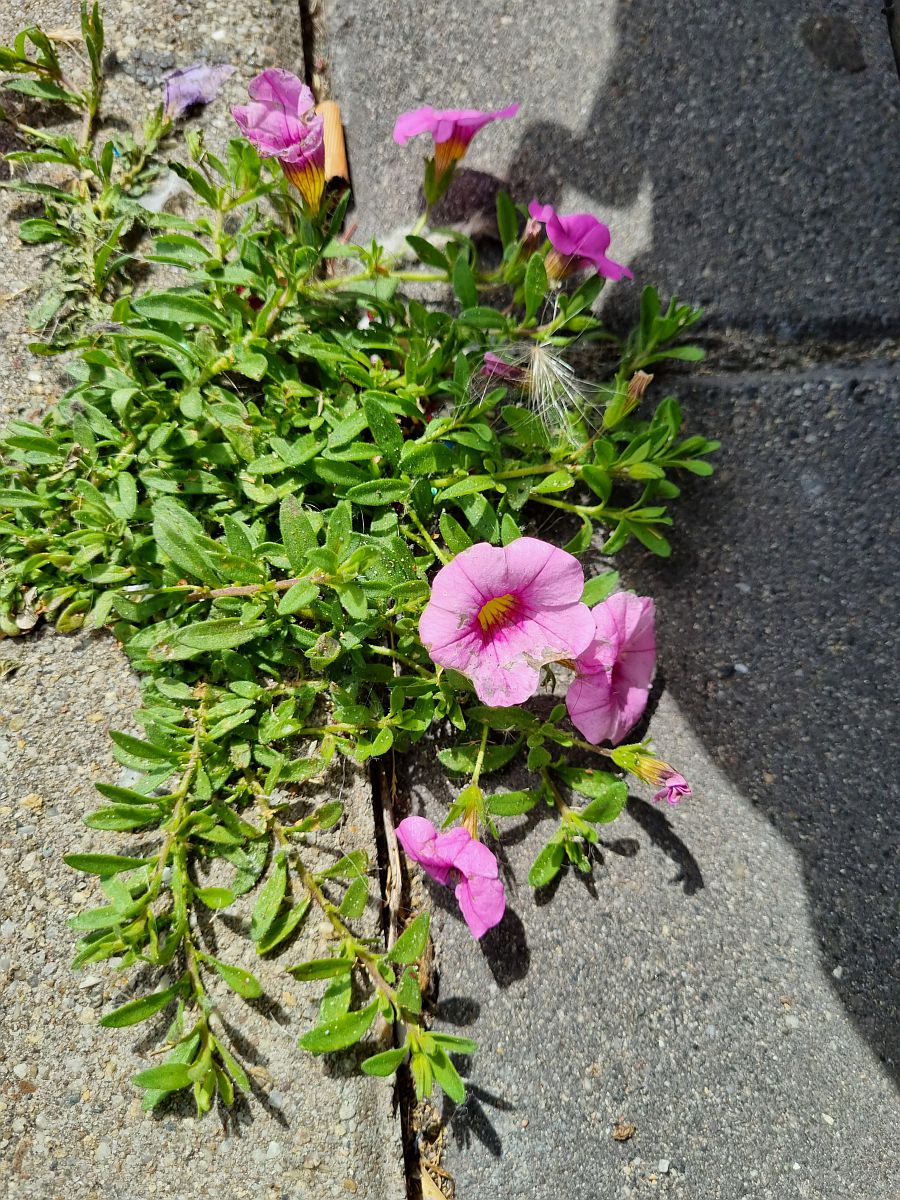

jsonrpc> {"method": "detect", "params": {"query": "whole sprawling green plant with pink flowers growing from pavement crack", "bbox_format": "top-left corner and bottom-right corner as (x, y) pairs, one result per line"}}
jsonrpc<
(0, 6), (715, 1112)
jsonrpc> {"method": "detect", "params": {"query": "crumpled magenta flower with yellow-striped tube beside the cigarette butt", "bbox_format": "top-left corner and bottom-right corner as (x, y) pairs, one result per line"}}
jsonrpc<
(232, 67), (325, 212)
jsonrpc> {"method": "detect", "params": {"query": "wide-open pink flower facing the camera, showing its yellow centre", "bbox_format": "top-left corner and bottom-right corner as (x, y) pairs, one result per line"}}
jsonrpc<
(419, 538), (594, 708)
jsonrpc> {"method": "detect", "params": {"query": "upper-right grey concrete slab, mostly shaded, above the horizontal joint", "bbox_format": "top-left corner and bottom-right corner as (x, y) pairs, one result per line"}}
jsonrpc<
(325, 0), (900, 338)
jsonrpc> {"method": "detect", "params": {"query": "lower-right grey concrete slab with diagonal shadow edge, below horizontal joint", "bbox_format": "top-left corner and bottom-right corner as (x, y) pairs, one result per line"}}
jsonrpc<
(412, 372), (900, 1200)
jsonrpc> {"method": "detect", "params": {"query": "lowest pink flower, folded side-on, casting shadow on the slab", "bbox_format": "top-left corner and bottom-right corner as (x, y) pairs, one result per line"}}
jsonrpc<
(397, 817), (506, 937)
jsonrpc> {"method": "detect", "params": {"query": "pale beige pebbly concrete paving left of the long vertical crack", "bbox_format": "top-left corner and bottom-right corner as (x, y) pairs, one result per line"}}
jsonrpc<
(0, 0), (406, 1200)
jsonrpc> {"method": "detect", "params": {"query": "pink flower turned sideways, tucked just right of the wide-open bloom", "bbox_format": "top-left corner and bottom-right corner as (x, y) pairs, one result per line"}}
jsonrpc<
(565, 592), (656, 743)
